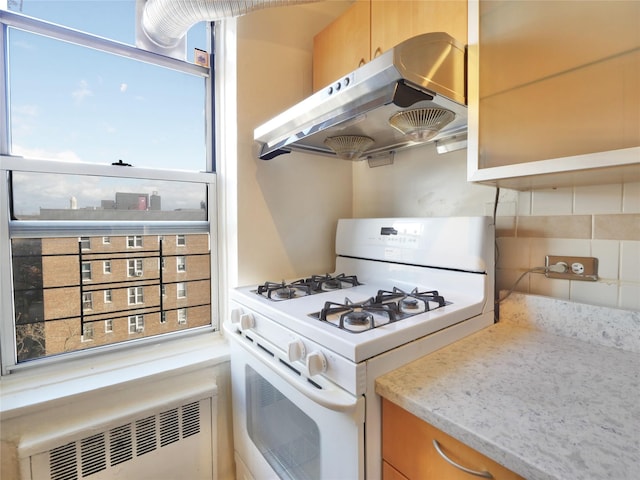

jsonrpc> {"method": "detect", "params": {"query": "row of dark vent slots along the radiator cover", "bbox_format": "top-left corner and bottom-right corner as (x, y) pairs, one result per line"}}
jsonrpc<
(47, 401), (202, 480)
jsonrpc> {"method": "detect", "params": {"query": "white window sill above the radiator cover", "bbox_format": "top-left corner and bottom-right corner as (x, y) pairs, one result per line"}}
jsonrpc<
(0, 332), (229, 421)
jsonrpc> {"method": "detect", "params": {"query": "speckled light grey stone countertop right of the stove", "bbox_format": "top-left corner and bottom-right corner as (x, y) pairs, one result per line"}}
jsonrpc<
(376, 295), (640, 480)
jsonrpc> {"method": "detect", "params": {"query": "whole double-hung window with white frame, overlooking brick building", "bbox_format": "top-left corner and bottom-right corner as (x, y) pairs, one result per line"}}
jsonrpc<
(0, 4), (218, 374)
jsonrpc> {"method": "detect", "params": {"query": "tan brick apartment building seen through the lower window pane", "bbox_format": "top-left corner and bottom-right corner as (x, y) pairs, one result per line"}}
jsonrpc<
(13, 193), (211, 361)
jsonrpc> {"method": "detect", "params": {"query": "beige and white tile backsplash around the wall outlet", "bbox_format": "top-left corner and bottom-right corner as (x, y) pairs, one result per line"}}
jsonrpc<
(496, 182), (640, 310)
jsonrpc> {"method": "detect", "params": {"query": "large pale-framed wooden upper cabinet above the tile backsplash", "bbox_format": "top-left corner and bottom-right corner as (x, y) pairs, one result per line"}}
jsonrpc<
(469, 0), (640, 188)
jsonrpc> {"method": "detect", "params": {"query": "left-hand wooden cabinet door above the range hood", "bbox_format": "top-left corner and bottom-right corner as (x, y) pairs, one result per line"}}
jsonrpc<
(313, 0), (370, 92)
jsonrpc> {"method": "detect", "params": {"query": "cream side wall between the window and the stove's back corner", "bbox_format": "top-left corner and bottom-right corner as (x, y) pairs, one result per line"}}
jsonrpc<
(237, 1), (352, 285)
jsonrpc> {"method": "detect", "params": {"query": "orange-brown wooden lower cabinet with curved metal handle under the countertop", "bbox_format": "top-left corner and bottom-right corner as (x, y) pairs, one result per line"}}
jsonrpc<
(382, 399), (524, 480)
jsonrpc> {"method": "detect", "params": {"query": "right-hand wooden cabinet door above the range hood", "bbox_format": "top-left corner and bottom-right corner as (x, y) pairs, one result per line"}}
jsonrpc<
(371, 0), (467, 58)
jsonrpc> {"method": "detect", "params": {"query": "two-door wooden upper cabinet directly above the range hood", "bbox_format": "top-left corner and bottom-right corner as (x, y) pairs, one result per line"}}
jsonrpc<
(313, 0), (467, 91)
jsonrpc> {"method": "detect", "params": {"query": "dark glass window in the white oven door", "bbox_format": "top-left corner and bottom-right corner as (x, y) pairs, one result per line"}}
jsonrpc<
(245, 365), (321, 480)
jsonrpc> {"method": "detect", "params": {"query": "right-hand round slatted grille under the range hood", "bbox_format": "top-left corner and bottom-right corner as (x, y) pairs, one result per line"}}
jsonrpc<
(389, 108), (456, 142)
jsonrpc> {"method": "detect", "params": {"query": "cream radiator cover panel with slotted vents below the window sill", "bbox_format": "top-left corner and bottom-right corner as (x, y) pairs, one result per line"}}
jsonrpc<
(29, 397), (215, 480)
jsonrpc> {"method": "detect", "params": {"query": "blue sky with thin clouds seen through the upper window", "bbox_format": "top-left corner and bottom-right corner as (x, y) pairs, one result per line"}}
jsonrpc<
(9, 0), (205, 170)
